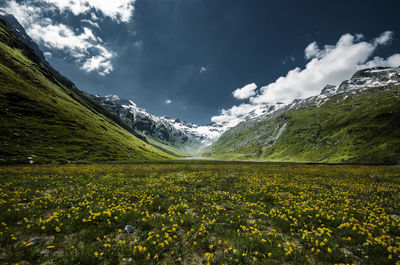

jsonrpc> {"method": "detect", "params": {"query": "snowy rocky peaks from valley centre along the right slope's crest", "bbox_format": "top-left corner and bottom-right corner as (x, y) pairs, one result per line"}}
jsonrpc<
(92, 68), (400, 153)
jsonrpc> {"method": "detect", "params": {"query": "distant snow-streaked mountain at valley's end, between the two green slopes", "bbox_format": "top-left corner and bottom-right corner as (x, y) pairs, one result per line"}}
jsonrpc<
(88, 95), (227, 154)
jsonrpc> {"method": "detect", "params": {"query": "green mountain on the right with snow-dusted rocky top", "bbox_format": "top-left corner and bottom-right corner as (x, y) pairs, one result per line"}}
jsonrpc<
(203, 68), (400, 163)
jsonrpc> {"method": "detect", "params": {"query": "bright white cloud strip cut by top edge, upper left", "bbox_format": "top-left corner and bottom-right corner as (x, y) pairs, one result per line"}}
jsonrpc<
(41, 0), (136, 22)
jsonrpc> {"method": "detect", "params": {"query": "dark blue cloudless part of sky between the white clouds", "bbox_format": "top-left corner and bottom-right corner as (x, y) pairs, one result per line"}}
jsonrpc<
(3, 0), (400, 124)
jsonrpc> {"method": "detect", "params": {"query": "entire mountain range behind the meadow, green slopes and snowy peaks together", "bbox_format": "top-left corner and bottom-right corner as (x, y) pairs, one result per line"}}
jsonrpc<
(0, 10), (400, 163)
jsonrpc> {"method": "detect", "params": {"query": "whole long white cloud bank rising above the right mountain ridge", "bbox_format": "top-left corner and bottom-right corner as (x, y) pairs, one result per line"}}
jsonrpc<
(211, 31), (400, 126)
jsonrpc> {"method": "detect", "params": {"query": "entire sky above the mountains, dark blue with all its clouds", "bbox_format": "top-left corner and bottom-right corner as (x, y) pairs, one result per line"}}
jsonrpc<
(0, 0), (400, 124)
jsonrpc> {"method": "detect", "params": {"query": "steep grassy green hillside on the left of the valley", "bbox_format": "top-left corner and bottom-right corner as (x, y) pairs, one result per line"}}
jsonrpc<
(0, 21), (172, 163)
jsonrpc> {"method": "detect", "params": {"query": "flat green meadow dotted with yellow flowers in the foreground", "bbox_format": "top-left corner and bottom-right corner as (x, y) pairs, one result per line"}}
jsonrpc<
(0, 161), (400, 265)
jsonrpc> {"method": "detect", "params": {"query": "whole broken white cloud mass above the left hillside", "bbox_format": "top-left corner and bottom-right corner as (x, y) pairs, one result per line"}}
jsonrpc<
(0, 0), (136, 76)
